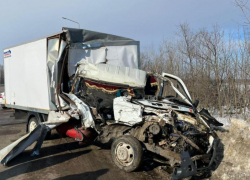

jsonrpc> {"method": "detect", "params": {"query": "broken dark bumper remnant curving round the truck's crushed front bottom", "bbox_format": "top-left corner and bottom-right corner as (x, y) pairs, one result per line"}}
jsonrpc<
(172, 138), (220, 180)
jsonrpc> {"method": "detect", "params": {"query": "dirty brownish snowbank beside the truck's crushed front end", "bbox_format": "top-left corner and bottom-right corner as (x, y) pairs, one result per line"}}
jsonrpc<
(209, 118), (250, 180)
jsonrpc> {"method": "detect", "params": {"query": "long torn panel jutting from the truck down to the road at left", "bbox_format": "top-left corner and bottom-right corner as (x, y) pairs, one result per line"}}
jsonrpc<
(0, 124), (50, 165)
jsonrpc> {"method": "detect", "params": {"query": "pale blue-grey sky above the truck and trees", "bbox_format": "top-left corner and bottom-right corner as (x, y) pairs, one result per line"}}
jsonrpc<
(0, 0), (244, 64)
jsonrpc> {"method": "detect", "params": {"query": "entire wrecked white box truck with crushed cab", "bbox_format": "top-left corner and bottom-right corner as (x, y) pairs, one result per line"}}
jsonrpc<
(0, 28), (222, 179)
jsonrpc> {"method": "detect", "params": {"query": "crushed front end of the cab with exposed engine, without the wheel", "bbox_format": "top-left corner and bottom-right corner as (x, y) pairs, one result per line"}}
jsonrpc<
(64, 71), (221, 179)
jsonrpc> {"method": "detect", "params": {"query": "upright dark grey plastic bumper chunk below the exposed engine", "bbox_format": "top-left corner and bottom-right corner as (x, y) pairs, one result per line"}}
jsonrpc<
(172, 151), (197, 180)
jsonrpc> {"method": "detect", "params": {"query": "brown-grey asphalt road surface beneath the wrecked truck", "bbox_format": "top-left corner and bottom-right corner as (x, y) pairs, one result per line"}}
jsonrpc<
(0, 109), (171, 180)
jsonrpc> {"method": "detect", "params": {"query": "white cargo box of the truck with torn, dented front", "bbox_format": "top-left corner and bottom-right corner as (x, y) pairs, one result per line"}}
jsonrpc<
(4, 28), (140, 114)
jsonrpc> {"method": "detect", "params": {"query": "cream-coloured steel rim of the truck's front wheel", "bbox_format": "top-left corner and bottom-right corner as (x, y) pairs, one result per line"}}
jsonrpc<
(115, 142), (134, 166)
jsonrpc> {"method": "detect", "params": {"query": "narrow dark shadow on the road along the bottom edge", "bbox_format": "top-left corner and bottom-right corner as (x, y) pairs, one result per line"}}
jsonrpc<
(54, 169), (109, 180)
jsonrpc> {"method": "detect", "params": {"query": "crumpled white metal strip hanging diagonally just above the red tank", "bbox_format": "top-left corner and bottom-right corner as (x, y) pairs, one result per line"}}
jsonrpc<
(64, 93), (95, 128)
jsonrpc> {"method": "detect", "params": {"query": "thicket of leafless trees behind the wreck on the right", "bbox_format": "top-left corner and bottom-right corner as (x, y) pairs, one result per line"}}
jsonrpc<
(141, 23), (250, 119)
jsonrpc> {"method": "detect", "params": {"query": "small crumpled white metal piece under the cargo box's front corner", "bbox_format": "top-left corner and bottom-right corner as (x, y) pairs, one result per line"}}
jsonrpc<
(43, 111), (70, 124)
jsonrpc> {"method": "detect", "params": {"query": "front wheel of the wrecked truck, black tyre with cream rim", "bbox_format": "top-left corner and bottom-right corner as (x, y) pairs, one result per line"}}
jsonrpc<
(111, 136), (143, 172)
